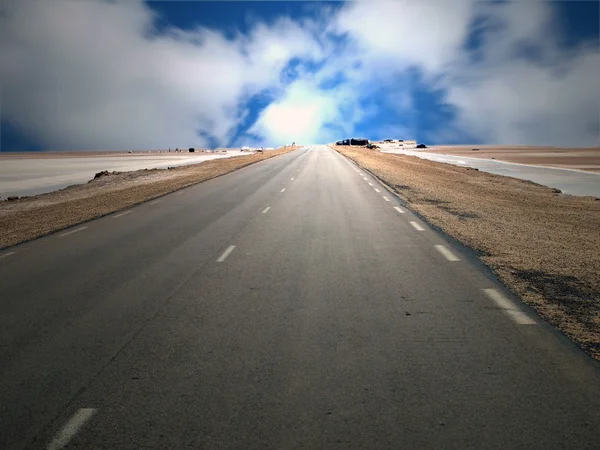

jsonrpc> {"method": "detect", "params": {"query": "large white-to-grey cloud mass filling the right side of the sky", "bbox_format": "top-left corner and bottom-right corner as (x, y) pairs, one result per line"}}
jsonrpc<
(331, 0), (600, 146)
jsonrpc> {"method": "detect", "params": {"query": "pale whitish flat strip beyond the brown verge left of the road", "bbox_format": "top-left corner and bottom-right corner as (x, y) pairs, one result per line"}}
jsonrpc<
(0, 150), (247, 198)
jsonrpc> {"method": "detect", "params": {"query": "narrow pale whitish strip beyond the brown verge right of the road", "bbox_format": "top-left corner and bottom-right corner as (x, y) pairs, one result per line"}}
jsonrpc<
(383, 149), (600, 198)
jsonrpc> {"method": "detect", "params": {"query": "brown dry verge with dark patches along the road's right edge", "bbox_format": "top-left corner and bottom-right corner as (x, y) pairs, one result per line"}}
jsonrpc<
(332, 146), (600, 360)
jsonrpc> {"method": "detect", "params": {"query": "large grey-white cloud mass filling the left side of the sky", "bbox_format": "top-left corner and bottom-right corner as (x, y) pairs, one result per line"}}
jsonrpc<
(0, 0), (320, 149)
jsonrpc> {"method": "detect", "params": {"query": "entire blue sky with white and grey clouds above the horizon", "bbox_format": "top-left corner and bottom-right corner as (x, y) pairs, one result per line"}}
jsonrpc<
(0, 0), (600, 151)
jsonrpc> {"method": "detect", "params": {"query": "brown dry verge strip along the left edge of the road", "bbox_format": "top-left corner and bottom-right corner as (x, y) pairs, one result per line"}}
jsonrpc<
(0, 147), (298, 249)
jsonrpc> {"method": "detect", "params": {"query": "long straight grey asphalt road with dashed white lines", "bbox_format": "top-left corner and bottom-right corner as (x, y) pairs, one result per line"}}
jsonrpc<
(0, 146), (600, 449)
